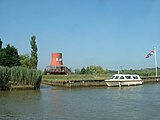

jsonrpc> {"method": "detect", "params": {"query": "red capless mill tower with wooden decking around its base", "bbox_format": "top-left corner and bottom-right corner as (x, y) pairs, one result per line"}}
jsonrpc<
(45, 53), (71, 75)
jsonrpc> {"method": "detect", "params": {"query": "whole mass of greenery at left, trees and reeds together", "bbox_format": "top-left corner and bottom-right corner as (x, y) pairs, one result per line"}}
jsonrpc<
(0, 36), (42, 90)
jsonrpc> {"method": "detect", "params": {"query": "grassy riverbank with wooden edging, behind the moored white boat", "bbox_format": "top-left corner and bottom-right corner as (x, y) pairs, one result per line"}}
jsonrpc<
(42, 75), (160, 87)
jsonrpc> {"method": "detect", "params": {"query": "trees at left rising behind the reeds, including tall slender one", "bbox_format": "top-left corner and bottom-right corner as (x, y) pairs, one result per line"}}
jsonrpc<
(0, 36), (38, 69)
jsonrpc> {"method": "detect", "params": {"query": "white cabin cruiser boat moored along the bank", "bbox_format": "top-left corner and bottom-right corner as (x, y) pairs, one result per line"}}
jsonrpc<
(105, 74), (143, 87)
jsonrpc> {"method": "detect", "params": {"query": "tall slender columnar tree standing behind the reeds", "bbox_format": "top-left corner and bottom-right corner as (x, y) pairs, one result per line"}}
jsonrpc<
(30, 36), (38, 69)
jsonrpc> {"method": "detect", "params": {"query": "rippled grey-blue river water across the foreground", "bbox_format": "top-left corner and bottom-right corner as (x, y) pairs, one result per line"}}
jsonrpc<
(0, 83), (160, 120)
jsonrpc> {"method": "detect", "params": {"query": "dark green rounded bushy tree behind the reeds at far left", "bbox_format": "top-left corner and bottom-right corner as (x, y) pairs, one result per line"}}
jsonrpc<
(0, 44), (20, 67)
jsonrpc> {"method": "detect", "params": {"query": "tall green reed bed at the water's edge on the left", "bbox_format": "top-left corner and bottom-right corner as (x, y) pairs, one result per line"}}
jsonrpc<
(0, 66), (42, 89)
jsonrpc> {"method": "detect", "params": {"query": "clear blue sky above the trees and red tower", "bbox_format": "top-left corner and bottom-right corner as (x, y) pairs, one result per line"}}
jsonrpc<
(0, 0), (160, 70)
